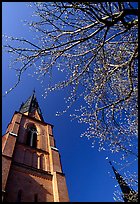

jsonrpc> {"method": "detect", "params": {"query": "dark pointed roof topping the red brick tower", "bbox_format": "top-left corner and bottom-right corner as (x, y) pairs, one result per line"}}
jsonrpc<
(19, 90), (44, 121)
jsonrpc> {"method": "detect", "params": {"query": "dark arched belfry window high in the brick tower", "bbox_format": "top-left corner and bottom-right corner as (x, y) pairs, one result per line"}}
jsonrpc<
(26, 126), (37, 147)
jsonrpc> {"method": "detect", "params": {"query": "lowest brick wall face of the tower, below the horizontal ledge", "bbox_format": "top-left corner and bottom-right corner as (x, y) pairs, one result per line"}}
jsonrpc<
(6, 166), (54, 202)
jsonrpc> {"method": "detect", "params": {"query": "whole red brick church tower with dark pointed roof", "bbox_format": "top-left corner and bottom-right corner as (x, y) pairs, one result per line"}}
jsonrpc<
(2, 91), (69, 202)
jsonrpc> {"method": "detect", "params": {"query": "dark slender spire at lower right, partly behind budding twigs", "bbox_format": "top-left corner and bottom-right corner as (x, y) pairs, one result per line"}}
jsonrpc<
(109, 161), (138, 202)
